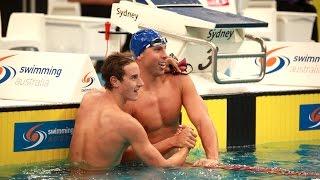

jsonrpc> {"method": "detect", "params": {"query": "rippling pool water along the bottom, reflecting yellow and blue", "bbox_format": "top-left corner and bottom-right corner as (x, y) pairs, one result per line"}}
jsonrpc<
(0, 140), (320, 179)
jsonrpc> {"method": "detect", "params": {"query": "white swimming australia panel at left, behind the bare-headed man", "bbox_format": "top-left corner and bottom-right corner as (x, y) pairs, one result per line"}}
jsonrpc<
(0, 51), (101, 103)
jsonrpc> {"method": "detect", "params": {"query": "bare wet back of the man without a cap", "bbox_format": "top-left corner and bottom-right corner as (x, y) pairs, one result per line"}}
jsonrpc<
(70, 90), (128, 169)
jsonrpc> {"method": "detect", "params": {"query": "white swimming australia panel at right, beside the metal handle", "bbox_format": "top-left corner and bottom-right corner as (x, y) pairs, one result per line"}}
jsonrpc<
(256, 42), (320, 87)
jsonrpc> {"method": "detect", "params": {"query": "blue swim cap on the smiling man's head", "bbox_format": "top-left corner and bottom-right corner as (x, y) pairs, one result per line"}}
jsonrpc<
(130, 29), (167, 57)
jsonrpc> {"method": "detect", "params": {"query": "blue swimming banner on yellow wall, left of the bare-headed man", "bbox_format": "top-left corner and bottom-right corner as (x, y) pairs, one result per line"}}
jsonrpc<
(14, 120), (74, 152)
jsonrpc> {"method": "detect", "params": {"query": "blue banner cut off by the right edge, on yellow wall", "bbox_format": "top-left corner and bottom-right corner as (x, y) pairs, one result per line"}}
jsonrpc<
(299, 104), (320, 131)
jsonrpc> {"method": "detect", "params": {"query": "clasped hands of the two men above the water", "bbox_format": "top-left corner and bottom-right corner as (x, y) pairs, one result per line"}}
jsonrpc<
(173, 126), (197, 149)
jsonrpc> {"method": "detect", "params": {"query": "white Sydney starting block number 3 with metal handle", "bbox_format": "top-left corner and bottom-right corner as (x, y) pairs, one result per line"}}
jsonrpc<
(111, 0), (267, 83)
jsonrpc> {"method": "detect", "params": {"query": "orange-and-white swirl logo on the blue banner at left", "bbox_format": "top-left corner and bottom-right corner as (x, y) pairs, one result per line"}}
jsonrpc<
(23, 124), (48, 149)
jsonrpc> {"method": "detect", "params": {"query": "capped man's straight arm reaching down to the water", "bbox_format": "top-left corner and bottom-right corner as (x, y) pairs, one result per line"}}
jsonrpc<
(180, 76), (219, 160)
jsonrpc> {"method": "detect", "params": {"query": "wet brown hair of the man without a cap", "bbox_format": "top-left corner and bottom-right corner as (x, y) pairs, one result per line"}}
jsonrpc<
(101, 52), (135, 90)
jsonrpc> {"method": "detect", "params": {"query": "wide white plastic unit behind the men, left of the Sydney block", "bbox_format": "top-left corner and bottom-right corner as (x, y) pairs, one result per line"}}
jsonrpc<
(45, 15), (121, 60)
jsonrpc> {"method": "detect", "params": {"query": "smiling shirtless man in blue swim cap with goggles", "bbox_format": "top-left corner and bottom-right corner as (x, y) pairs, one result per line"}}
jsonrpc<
(122, 29), (219, 167)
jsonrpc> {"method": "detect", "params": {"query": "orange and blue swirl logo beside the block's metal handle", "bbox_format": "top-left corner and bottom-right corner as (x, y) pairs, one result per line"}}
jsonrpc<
(256, 46), (290, 74)
